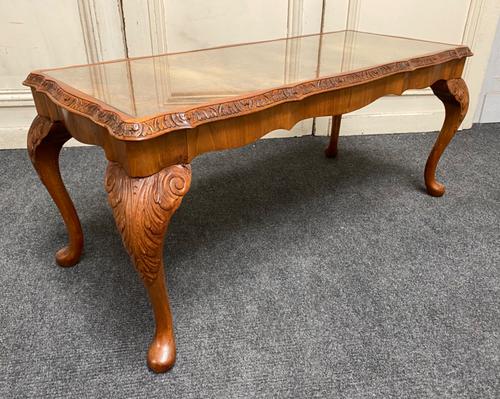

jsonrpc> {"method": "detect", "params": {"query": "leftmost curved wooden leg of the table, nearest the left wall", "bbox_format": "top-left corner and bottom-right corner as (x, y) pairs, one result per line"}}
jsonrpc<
(27, 116), (83, 267)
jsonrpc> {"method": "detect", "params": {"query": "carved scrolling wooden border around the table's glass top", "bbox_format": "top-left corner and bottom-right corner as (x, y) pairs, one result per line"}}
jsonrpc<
(23, 46), (473, 141)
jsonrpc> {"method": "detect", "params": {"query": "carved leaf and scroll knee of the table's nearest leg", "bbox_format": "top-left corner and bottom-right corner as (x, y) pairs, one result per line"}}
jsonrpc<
(105, 162), (191, 283)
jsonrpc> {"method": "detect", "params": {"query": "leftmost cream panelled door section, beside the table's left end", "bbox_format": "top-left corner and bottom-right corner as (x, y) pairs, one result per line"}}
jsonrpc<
(0, 0), (125, 148)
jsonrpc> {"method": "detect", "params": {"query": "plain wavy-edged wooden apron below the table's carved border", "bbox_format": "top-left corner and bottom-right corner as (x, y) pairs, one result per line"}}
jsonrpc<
(28, 58), (465, 177)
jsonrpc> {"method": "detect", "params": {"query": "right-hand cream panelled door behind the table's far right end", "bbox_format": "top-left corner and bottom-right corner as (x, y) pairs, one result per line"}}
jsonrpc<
(316, 0), (500, 134)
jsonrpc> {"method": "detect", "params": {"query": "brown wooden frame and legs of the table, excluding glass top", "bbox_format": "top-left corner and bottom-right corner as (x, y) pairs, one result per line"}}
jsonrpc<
(25, 36), (471, 372)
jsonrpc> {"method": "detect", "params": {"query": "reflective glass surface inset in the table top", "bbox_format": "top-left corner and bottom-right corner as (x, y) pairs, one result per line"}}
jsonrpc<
(37, 31), (463, 118)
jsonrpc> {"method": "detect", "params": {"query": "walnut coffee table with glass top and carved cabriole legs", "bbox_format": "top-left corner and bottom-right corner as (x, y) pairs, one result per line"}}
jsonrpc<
(24, 31), (472, 372)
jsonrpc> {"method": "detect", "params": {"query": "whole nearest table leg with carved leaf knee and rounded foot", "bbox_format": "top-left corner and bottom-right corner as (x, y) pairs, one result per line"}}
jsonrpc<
(105, 162), (191, 373)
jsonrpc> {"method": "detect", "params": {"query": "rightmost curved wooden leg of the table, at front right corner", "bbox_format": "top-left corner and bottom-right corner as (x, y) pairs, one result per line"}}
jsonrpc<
(424, 79), (469, 197)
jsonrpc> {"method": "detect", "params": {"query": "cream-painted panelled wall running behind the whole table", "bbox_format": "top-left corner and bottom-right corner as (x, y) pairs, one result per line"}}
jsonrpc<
(0, 0), (500, 148)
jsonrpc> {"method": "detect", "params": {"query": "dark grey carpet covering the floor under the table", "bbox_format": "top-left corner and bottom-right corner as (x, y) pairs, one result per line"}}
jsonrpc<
(0, 124), (500, 398)
